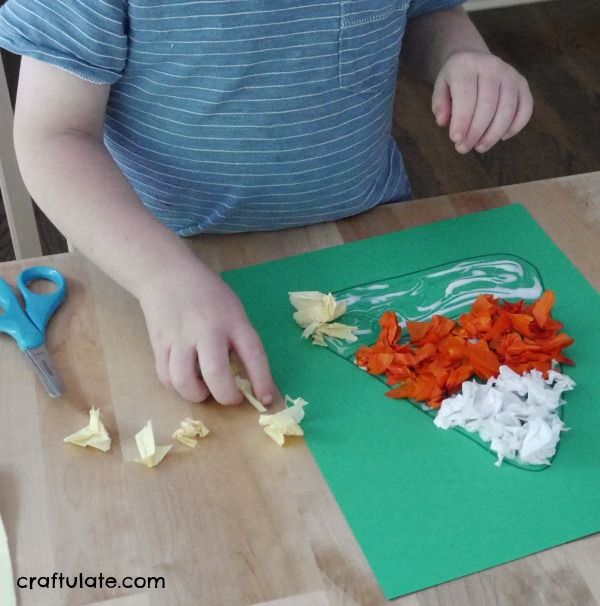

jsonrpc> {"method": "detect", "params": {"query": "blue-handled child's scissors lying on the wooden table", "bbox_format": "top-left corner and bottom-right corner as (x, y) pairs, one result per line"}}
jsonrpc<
(0, 267), (67, 398)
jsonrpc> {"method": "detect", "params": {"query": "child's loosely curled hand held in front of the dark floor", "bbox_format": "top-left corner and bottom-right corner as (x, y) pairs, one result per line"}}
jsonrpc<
(431, 52), (533, 154)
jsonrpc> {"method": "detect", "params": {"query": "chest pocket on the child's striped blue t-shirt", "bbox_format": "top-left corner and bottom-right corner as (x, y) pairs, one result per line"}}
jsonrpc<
(339, 0), (409, 92)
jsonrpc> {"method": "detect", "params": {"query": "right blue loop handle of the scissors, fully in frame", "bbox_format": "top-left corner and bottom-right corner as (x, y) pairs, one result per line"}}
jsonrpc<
(17, 266), (67, 334)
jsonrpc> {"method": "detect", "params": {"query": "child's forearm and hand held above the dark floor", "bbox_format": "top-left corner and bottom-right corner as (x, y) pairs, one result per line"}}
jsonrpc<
(402, 8), (533, 154)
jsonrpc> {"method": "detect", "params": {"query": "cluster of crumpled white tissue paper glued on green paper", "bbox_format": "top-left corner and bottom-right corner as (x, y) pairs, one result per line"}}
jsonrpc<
(433, 366), (575, 466)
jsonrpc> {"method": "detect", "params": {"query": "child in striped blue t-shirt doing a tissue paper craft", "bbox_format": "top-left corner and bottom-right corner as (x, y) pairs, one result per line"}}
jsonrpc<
(0, 0), (532, 404)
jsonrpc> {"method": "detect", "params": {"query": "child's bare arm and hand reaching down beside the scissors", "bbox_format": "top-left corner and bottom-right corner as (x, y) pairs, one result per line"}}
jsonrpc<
(15, 57), (275, 404)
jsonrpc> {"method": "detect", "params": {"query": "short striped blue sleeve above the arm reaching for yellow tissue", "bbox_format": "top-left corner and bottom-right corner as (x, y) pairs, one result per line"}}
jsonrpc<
(0, 0), (127, 84)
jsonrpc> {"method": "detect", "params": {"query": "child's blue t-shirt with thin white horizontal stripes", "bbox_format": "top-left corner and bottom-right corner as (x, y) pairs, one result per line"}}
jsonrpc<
(0, 0), (464, 236)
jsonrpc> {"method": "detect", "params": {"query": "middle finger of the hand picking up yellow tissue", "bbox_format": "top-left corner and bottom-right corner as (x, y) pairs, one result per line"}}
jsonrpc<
(198, 333), (243, 404)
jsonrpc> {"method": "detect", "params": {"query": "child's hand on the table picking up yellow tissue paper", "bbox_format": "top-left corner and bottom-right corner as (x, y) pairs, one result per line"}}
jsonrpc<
(139, 264), (275, 404)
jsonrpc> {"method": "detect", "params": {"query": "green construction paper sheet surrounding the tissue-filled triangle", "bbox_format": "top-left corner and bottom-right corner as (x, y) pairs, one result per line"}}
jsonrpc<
(224, 204), (600, 599)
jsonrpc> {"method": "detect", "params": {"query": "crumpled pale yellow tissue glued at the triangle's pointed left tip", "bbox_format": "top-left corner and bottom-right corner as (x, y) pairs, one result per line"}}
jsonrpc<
(288, 291), (357, 347)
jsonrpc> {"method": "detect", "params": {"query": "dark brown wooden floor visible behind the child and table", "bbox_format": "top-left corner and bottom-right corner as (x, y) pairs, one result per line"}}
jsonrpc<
(0, 0), (600, 261)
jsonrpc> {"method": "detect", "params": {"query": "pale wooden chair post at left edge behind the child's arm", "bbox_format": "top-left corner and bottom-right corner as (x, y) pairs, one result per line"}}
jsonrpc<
(0, 61), (42, 259)
